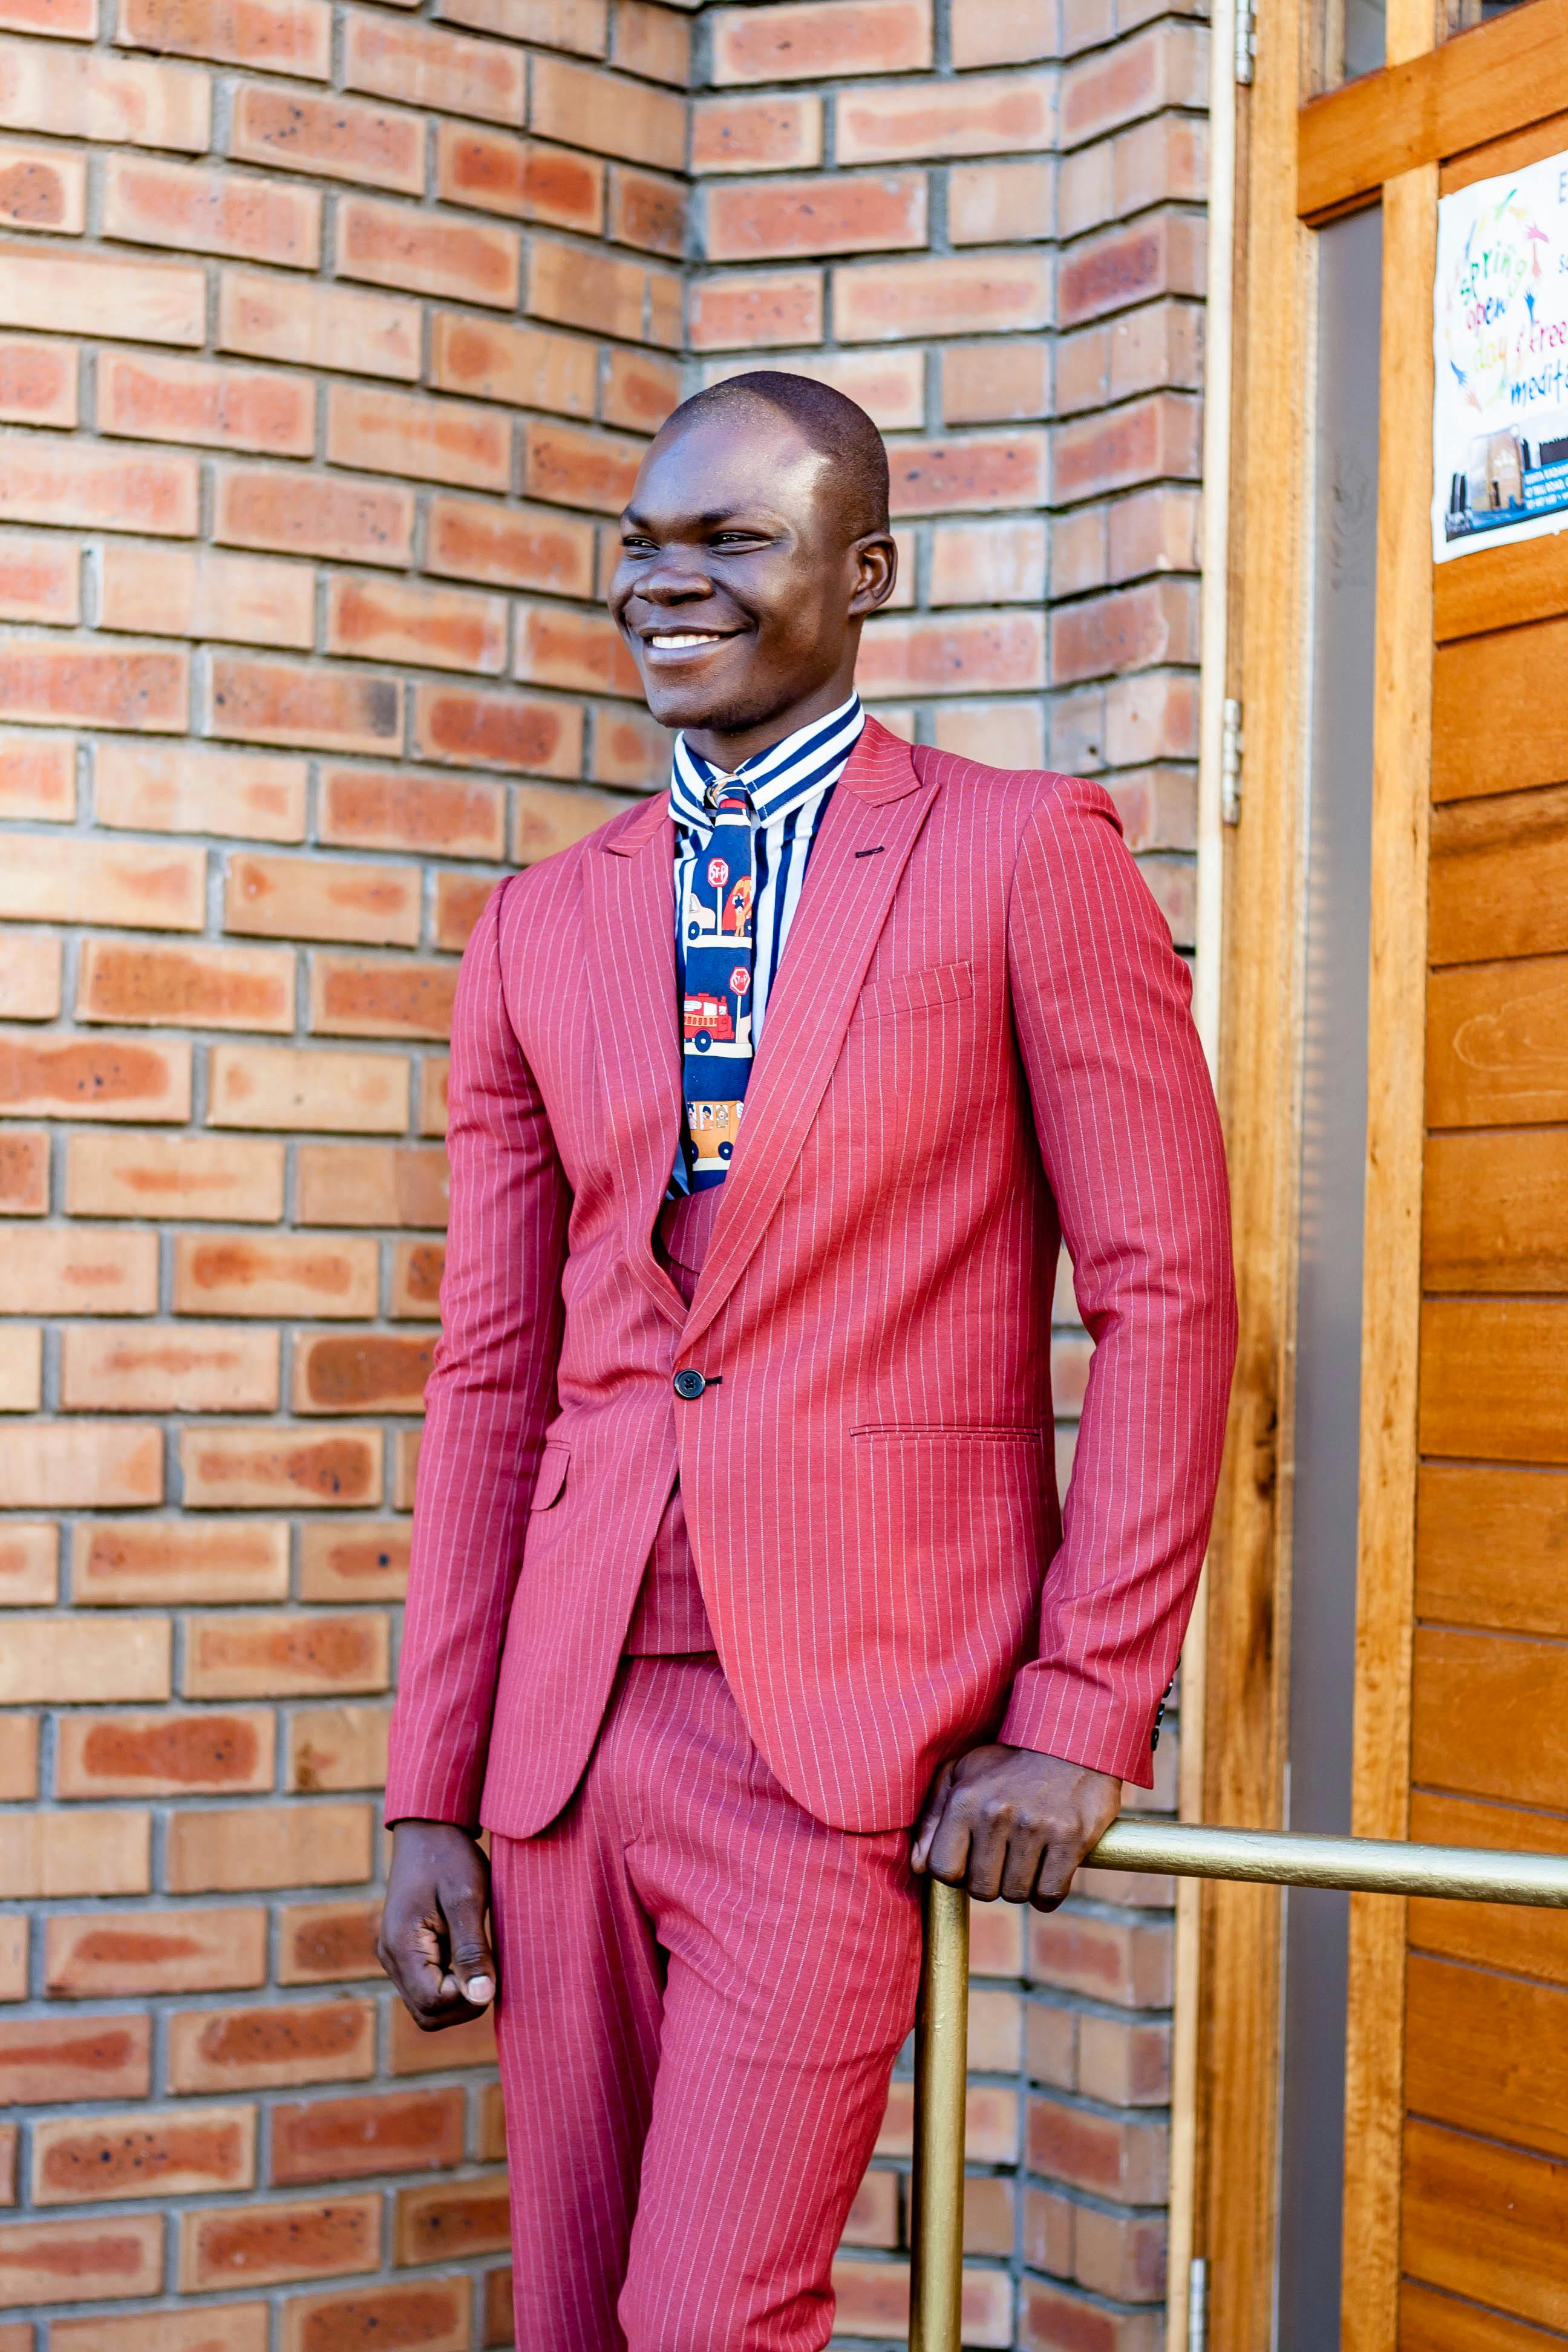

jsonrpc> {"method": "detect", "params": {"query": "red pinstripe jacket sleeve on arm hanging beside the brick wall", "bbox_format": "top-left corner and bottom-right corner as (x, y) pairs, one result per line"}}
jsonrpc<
(385, 884), (571, 1828)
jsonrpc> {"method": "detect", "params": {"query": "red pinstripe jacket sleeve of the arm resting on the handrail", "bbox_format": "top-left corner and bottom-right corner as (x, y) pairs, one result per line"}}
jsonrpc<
(999, 779), (1236, 1788)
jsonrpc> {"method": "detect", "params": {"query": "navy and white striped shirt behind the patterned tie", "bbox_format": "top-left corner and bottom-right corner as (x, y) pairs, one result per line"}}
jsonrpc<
(670, 694), (865, 1192)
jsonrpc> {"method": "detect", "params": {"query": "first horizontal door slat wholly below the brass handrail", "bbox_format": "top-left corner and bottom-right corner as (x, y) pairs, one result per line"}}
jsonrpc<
(1406, 1952), (1568, 2157)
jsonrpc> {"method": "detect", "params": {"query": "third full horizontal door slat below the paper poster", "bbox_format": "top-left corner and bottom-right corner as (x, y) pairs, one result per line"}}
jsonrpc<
(1427, 959), (1568, 1126)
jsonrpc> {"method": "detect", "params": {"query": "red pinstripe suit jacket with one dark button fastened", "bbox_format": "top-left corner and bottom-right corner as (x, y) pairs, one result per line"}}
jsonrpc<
(388, 722), (1234, 1837)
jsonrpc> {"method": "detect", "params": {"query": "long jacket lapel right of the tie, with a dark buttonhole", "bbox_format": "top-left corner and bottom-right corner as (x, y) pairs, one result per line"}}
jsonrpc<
(682, 720), (938, 1348)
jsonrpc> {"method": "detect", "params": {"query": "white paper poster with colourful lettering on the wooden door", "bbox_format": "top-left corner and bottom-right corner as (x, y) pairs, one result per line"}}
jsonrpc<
(1432, 155), (1568, 562)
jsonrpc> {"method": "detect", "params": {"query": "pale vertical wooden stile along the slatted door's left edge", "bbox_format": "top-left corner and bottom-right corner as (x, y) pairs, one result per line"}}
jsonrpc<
(1340, 151), (1436, 2352)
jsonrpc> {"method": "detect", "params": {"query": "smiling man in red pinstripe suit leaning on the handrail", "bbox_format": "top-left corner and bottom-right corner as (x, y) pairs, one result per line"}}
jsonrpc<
(381, 371), (1234, 2352)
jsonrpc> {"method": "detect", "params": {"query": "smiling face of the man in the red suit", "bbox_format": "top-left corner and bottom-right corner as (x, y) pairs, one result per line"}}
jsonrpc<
(609, 405), (896, 739)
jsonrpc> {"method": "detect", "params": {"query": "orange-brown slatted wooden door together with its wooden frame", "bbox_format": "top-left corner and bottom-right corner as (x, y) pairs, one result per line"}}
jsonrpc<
(1194, 0), (1568, 2352)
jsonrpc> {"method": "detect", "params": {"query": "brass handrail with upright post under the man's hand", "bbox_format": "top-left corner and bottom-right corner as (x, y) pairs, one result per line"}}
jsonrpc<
(910, 1816), (1568, 2352)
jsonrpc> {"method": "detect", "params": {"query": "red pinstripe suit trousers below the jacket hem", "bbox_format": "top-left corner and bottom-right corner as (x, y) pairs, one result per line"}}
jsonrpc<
(491, 1653), (919, 2352)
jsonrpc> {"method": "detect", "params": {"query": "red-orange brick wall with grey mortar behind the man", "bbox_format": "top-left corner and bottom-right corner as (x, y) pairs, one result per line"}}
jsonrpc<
(0, 0), (1204, 2352)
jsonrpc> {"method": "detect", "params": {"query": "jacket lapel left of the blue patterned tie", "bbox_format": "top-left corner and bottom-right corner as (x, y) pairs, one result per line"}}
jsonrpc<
(586, 795), (687, 1324)
